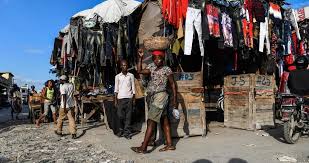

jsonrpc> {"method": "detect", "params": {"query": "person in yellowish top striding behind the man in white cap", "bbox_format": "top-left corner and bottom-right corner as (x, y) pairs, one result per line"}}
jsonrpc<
(36, 80), (57, 127)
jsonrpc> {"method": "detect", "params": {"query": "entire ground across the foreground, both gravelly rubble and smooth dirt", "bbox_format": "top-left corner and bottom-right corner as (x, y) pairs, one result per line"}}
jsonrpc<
(0, 106), (309, 163)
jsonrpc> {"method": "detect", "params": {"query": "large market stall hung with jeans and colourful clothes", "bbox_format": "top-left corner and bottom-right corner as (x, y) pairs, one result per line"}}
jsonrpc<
(50, 0), (308, 136)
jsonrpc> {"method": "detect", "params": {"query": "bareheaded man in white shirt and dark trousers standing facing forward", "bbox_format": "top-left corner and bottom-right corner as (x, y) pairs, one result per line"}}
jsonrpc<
(115, 60), (135, 139)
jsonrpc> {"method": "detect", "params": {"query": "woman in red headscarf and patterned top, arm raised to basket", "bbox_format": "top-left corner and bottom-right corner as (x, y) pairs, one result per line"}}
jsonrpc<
(131, 49), (177, 153)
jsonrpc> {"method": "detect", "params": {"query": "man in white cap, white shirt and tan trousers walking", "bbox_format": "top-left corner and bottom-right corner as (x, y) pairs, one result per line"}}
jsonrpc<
(55, 75), (77, 139)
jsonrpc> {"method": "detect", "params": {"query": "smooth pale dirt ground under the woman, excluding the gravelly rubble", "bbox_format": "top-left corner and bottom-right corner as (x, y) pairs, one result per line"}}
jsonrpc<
(80, 121), (309, 163)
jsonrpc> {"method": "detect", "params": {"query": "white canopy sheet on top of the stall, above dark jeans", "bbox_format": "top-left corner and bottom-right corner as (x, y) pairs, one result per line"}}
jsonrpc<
(83, 0), (141, 23)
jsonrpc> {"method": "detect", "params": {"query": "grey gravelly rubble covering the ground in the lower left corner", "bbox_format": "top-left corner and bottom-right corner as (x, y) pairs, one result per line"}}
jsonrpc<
(0, 125), (127, 163)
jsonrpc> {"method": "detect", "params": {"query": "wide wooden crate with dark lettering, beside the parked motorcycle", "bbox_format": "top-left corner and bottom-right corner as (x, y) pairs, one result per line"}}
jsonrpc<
(224, 74), (275, 130)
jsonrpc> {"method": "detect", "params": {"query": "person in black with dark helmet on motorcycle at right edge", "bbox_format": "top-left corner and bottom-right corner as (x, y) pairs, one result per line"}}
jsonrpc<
(288, 56), (309, 96)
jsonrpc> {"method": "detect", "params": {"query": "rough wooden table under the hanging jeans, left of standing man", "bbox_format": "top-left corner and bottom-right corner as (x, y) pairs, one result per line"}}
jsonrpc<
(76, 95), (114, 129)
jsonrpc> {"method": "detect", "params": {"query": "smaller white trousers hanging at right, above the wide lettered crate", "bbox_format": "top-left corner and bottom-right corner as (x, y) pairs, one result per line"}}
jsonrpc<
(259, 17), (270, 54)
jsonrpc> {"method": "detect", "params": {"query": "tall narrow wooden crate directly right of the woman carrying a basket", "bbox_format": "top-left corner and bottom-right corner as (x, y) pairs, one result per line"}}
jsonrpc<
(170, 72), (206, 137)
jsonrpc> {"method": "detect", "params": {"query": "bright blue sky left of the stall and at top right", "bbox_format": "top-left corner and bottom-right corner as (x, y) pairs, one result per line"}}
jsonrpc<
(0, 0), (309, 88)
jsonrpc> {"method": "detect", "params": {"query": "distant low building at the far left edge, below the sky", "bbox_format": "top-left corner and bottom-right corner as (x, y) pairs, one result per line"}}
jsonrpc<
(0, 72), (14, 105)
